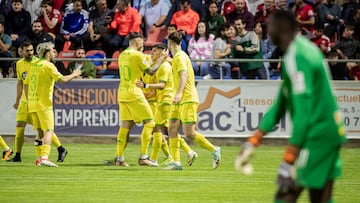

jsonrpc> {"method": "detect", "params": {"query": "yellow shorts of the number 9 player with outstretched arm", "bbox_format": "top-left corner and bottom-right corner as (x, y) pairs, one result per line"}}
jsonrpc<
(30, 109), (54, 132)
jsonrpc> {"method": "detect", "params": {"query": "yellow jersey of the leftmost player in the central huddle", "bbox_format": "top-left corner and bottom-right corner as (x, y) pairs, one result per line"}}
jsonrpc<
(118, 48), (150, 102)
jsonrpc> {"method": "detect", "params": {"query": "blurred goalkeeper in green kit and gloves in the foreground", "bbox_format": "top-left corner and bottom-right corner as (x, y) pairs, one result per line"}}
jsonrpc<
(235, 10), (346, 203)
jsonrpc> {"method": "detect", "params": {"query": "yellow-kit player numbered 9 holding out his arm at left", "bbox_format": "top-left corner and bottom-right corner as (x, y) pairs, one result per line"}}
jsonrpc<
(24, 43), (81, 167)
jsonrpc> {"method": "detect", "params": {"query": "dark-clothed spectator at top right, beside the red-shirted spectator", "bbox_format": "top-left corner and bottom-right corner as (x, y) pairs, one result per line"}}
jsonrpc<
(317, 0), (344, 39)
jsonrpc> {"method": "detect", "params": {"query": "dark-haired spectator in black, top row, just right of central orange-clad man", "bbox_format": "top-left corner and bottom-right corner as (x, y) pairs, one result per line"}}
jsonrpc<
(203, 0), (225, 35)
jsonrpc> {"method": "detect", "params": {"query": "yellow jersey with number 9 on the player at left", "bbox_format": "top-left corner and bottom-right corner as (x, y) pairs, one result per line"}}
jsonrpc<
(24, 59), (63, 113)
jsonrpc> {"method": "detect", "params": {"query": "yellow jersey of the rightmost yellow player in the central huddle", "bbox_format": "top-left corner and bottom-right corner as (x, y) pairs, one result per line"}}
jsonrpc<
(172, 50), (199, 104)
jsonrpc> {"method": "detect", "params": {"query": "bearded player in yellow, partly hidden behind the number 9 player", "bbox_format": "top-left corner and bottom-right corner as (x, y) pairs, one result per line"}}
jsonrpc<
(9, 41), (68, 162)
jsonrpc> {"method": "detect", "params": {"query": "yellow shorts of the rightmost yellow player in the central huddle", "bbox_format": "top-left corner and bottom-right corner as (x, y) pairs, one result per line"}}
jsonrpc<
(169, 102), (199, 124)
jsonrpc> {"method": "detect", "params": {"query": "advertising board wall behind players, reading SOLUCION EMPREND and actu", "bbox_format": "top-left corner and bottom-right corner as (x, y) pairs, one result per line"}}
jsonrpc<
(0, 79), (360, 139)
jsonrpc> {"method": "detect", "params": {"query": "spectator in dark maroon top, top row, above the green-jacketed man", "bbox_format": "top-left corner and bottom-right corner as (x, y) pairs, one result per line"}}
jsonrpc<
(226, 0), (254, 31)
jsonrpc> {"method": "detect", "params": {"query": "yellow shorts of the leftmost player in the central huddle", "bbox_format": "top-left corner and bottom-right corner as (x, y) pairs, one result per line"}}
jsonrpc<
(119, 100), (154, 123)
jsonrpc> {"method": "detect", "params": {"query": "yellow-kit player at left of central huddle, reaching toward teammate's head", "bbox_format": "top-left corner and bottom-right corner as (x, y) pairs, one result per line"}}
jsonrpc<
(116, 32), (167, 166)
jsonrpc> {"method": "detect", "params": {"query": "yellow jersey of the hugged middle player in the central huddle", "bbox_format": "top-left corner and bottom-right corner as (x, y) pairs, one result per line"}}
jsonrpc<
(155, 61), (174, 104)
